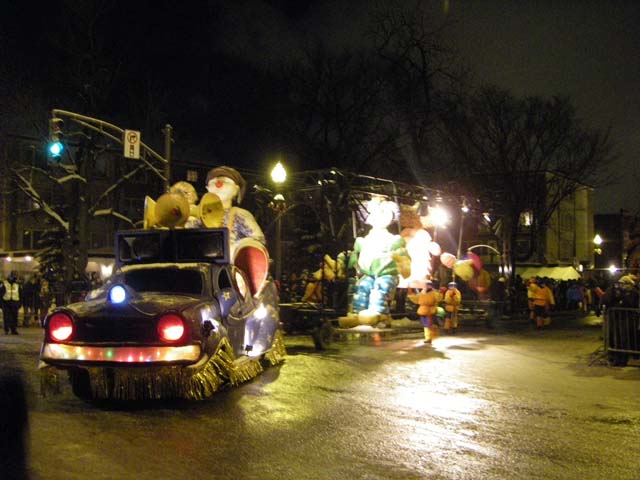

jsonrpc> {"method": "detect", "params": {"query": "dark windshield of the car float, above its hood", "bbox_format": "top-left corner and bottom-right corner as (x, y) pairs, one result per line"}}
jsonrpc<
(124, 268), (203, 295)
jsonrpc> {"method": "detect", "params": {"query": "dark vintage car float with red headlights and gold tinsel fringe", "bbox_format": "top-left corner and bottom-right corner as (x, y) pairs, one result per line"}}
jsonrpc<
(40, 229), (286, 400)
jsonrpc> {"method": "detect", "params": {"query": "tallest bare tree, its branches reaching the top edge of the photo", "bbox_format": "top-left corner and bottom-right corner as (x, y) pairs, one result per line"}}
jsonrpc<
(368, 2), (467, 186)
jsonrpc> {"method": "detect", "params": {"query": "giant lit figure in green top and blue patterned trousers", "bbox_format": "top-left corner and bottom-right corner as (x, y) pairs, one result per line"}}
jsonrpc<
(341, 197), (410, 326)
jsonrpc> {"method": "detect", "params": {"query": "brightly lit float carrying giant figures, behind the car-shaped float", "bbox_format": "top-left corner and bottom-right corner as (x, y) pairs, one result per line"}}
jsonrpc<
(270, 168), (478, 348)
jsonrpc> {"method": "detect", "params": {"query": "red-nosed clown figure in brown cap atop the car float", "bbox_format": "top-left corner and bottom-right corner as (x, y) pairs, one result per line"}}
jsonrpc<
(207, 167), (266, 258)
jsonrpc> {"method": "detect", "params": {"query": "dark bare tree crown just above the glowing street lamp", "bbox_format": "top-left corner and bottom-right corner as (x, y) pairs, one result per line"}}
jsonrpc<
(280, 44), (397, 175)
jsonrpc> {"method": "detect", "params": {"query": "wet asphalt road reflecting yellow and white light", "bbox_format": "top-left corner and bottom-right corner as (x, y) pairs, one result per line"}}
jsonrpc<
(0, 318), (640, 480)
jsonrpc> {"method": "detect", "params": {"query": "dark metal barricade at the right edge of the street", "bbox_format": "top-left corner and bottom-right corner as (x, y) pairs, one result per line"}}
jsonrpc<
(603, 307), (640, 367)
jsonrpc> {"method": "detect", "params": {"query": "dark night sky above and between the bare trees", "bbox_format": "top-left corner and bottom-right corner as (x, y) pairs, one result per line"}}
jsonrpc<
(0, 0), (640, 213)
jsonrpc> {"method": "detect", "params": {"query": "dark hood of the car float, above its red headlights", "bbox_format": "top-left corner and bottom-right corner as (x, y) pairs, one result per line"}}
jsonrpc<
(63, 293), (203, 317)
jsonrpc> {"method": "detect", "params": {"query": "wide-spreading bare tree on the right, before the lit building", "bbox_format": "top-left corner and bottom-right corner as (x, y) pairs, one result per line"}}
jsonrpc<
(442, 87), (614, 271)
